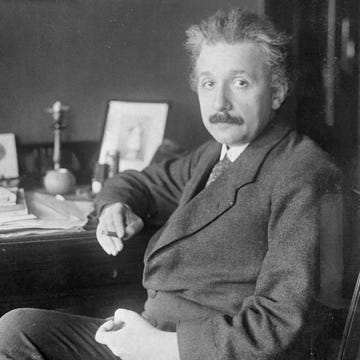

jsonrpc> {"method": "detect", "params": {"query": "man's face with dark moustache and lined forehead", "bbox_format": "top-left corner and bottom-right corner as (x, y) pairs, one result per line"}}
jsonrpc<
(195, 41), (282, 146)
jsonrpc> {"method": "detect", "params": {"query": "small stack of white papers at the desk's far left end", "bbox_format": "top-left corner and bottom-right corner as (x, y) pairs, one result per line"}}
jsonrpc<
(0, 187), (36, 225)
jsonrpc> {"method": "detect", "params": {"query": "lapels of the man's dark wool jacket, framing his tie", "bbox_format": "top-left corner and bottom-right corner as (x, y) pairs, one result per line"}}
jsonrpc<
(147, 122), (290, 259)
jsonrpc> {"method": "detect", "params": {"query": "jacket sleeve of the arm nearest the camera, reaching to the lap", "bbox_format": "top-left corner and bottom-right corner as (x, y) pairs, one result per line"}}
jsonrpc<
(177, 161), (342, 360)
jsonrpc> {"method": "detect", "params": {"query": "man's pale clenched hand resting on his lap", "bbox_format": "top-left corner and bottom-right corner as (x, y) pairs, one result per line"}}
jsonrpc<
(95, 309), (180, 360)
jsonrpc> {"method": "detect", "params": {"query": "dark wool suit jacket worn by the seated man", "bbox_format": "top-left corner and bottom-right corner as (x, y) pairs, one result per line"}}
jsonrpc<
(97, 122), (340, 360)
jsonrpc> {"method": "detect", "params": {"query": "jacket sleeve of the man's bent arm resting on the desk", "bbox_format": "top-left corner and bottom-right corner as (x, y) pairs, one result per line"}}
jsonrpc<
(95, 143), (214, 225)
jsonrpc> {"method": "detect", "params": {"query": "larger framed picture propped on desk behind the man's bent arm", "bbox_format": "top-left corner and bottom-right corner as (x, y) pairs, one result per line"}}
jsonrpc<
(99, 100), (169, 171)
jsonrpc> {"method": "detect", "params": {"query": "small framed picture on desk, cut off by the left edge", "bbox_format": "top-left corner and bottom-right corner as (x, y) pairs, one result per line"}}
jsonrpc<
(0, 133), (19, 180)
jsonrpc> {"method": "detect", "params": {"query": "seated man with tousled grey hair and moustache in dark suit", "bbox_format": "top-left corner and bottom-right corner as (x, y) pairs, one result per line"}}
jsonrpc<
(0, 10), (340, 360)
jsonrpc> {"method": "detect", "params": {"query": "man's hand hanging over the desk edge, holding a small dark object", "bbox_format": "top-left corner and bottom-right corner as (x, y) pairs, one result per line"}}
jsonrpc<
(96, 203), (144, 256)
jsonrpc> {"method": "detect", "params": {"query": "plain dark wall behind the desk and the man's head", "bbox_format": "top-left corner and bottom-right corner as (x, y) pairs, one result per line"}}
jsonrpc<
(0, 0), (264, 147)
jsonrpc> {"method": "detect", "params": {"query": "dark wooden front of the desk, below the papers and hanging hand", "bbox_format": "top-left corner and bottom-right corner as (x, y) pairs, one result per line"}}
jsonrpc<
(0, 231), (150, 316)
